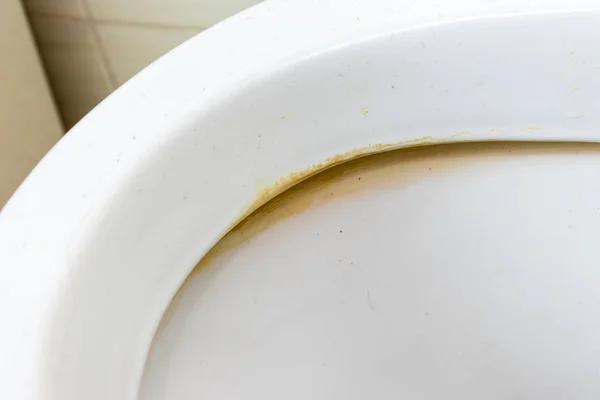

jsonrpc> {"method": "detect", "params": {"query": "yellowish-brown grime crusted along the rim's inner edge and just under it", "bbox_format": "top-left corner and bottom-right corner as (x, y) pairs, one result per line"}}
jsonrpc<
(194, 140), (597, 272)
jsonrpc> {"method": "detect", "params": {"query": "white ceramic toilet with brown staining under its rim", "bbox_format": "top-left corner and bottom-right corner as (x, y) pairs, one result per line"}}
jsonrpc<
(0, 0), (600, 400)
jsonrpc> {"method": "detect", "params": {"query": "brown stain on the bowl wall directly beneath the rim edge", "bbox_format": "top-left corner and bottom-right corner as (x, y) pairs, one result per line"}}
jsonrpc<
(152, 142), (600, 335)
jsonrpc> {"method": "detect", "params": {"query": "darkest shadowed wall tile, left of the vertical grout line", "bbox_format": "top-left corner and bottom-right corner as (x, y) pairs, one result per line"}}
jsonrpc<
(31, 16), (114, 128)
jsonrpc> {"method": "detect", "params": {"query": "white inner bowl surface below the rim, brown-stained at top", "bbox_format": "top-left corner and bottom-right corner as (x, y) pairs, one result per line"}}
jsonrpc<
(140, 143), (600, 400)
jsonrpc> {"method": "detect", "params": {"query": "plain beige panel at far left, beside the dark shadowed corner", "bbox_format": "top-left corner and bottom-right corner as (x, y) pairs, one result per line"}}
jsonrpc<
(0, 0), (63, 209)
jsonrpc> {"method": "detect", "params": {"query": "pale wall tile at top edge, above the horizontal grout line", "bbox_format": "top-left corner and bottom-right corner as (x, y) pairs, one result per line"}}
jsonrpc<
(87, 0), (260, 28)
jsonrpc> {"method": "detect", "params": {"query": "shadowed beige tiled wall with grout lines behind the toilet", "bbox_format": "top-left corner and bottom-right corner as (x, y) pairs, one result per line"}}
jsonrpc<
(23, 0), (260, 129)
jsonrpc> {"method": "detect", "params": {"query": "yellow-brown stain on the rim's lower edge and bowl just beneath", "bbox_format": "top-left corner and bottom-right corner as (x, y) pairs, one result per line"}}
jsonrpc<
(194, 141), (600, 273)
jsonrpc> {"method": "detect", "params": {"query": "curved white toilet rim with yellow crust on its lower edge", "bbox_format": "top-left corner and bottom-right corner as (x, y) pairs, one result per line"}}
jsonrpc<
(0, 0), (600, 400)
